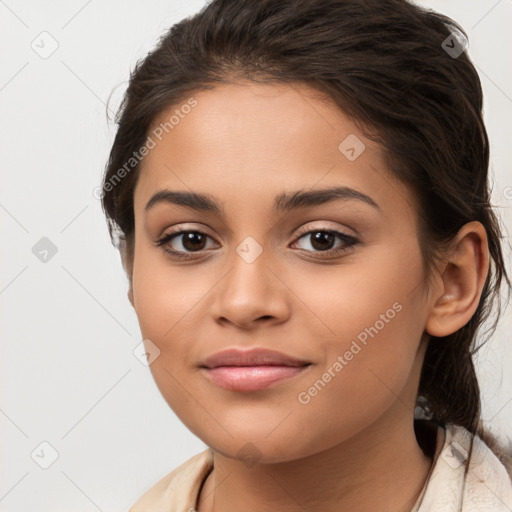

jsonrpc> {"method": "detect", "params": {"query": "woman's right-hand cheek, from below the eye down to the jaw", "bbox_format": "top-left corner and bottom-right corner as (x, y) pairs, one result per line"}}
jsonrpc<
(278, 245), (423, 442)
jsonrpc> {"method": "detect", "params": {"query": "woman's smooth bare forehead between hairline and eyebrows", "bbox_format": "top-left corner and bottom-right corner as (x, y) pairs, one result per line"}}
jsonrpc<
(135, 82), (416, 221)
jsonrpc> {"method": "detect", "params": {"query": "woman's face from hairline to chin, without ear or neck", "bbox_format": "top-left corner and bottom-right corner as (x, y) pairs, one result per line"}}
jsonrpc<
(132, 82), (429, 462)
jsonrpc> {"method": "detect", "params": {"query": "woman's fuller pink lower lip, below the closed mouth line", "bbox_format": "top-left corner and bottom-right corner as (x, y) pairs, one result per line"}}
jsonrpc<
(203, 365), (309, 391)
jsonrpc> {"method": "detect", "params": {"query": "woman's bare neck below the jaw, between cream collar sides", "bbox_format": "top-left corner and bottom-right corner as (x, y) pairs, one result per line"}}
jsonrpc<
(198, 408), (432, 512)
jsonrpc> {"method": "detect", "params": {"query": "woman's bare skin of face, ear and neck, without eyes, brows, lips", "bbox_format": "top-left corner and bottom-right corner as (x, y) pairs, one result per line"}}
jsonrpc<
(126, 81), (488, 512)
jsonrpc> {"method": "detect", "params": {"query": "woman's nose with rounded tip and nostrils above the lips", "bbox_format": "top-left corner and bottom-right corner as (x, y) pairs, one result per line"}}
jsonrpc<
(211, 245), (291, 330)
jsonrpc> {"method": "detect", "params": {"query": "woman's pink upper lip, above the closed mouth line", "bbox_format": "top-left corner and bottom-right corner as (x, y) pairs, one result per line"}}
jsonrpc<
(200, 348), (310, 368)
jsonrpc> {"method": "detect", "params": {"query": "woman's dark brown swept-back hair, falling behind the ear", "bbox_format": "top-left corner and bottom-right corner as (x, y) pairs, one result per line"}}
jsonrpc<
(102, 0), (510, 452)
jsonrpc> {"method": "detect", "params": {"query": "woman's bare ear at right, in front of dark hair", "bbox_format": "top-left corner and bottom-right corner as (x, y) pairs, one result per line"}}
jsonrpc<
(425, 221), (489, 337)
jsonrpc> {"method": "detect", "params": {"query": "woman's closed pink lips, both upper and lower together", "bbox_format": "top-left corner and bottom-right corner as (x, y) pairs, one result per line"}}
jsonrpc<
(200, 348), (311, 391)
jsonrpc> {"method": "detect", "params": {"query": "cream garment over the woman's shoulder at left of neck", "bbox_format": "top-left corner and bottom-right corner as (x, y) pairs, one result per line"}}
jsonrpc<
(129, 448), (213, 512)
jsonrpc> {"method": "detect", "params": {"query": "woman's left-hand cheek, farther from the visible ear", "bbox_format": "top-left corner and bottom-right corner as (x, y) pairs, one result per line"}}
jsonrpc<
(132, 244), (217, 420)
